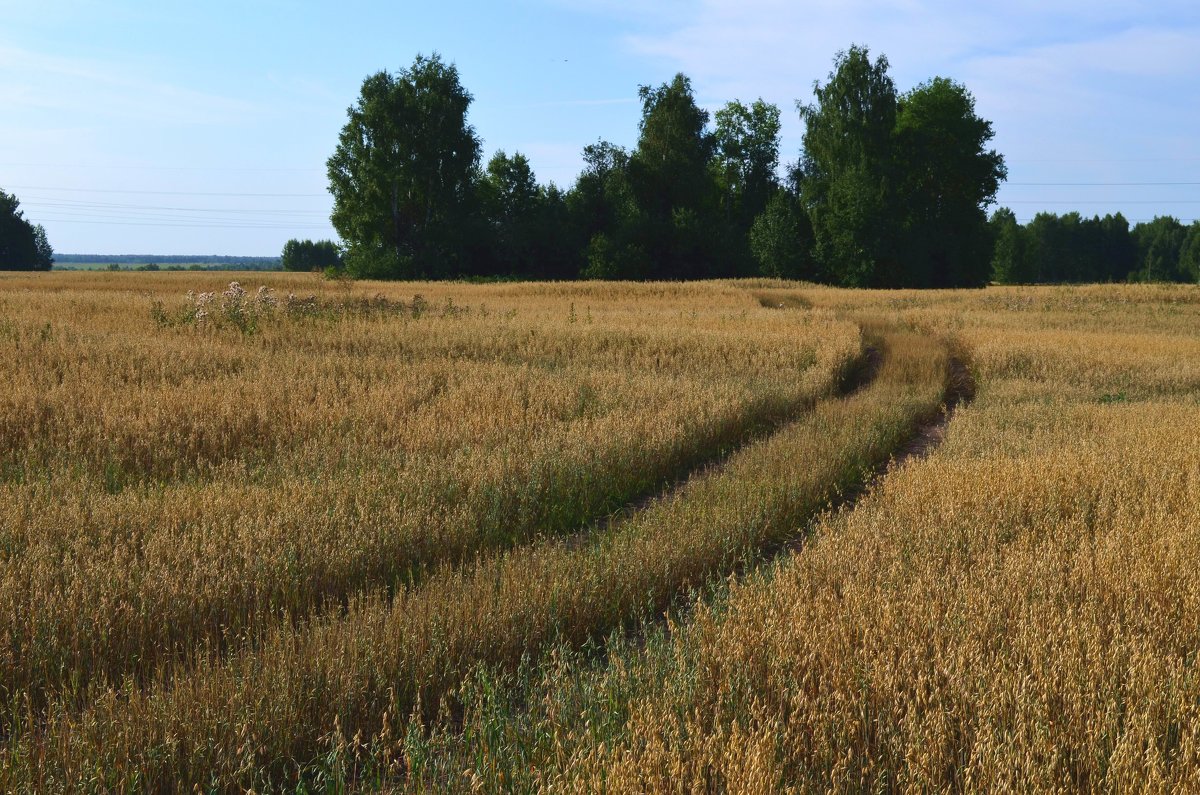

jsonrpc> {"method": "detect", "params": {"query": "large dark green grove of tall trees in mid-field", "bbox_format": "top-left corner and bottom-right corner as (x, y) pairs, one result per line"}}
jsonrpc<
(295, 47), (1006, 287)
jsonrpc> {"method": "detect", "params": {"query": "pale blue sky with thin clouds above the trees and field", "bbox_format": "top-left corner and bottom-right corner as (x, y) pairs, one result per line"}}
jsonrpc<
(0, 0), (1200, 255)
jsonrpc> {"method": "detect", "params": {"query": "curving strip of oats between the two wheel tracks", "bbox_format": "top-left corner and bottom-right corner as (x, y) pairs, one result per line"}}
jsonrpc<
(10, 321), (947, 789)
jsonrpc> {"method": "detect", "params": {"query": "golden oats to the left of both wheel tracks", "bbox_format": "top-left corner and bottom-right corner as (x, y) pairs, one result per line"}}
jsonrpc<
(0, 274), (859, 706)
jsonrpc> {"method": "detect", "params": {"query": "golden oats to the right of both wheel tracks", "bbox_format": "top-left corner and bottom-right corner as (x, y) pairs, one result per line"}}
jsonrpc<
(391, 287), (1200, 793)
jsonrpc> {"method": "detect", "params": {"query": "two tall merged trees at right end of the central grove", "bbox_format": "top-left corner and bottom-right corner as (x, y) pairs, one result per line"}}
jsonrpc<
(798, 47), (1006, 287)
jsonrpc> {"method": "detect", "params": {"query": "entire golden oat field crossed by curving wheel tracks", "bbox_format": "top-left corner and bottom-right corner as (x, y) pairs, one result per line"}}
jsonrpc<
(0, 273), (1200, 793)
